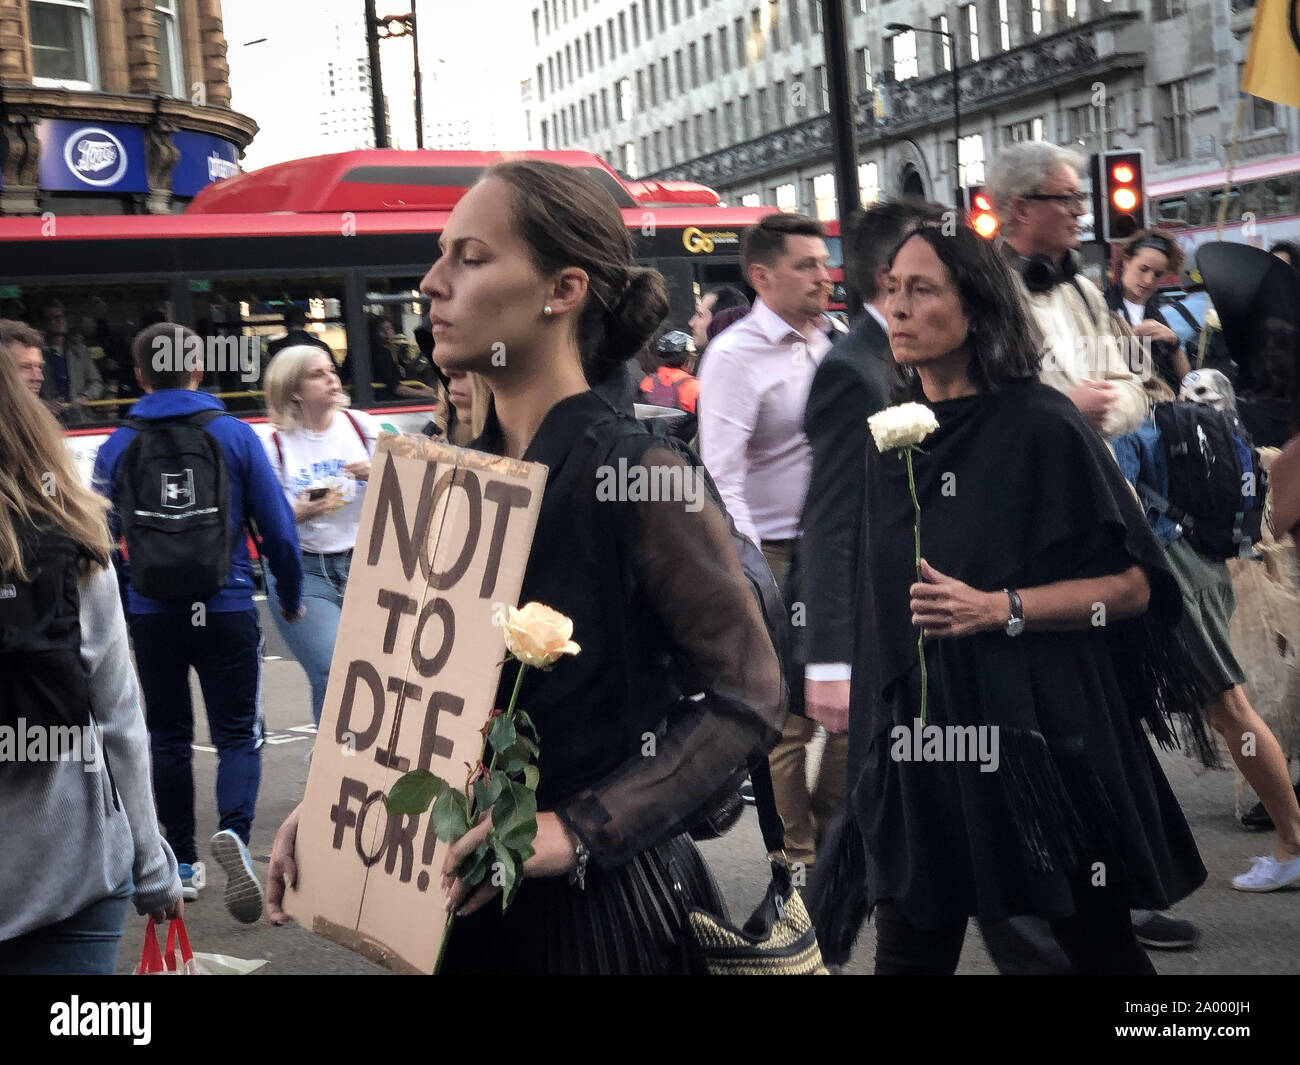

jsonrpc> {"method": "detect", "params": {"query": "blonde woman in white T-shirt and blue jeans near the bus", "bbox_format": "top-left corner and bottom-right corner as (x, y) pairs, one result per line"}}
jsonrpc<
(267, 345), (380, 722)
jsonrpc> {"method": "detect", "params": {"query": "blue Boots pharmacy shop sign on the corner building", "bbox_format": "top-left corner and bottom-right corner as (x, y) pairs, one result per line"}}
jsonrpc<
(36, 118), (239, 196)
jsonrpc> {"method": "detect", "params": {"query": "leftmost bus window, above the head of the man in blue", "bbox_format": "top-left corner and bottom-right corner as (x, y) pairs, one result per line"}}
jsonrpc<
(0, 280), (172, 428)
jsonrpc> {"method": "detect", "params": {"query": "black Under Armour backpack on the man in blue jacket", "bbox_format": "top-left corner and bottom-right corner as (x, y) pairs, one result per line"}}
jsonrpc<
(113, 410), (233, 602)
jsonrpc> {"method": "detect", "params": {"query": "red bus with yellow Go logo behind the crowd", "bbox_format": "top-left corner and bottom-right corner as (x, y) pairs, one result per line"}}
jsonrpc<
(0, 150), (772, 469)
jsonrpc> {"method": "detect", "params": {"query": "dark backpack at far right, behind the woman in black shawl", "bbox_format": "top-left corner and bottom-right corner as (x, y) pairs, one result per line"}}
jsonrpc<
(1139, 402), (1269, 559)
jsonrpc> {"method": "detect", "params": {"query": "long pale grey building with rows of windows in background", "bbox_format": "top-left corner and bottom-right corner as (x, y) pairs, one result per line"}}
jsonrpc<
(529, 0), (1300, 243)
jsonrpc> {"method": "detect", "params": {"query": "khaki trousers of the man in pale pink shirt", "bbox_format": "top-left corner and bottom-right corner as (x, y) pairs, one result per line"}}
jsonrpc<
(763, 540), (849, 867)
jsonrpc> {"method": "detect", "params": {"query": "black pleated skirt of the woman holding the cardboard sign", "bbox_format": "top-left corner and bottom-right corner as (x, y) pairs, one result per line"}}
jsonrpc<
(439, 835), (727, 975)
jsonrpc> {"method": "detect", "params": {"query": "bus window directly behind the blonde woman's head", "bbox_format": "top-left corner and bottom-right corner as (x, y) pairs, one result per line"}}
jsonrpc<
(190, 277), (347, 415)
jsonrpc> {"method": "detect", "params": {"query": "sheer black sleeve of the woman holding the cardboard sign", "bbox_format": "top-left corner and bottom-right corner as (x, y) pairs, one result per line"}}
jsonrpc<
(556, 445), (785, 867)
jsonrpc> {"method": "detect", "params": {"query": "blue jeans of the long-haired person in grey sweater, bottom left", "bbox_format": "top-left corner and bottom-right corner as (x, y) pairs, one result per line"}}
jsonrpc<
(0, 878), (133, 977)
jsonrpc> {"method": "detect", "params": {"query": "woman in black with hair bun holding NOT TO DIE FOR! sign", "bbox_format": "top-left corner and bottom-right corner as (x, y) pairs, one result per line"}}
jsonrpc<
(269, 161), (784, 973)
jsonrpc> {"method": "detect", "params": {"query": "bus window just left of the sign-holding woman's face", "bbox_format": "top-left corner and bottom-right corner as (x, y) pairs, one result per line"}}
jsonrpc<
(363, 277), (443, 407)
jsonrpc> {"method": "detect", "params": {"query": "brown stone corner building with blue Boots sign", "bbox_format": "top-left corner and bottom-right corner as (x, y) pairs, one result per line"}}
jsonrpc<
(0, 0), (257, 215)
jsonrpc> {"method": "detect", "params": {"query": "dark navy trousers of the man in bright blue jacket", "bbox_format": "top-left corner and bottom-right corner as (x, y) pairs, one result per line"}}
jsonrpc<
(130, 609), (265, 865)
